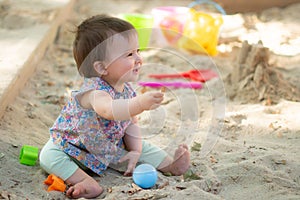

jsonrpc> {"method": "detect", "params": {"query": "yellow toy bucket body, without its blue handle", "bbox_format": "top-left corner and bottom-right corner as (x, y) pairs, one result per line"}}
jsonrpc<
(177, 8), (223, 55)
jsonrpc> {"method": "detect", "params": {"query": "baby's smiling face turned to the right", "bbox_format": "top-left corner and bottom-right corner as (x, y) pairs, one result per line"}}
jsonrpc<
(105, 31), (142, 84)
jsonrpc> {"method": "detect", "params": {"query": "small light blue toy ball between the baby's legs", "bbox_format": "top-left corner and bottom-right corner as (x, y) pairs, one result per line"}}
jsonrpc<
(132, 164), (157, 189)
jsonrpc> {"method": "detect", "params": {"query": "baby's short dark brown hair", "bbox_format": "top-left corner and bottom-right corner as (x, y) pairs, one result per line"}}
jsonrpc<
(73, 14), (134, 77)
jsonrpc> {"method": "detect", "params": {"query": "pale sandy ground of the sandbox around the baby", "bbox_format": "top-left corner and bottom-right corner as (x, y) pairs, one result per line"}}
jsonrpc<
(0, 0), (300, 200)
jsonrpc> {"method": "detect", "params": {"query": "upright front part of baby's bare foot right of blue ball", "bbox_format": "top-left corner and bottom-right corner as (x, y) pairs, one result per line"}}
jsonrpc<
(170, 144), (190, 176)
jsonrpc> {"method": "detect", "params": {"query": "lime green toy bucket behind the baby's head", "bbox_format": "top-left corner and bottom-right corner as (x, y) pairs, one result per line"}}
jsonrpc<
(120, 13), (153, 50)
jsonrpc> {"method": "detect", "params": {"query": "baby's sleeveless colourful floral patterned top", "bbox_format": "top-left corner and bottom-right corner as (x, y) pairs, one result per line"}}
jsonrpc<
(50, 77), (136, 174)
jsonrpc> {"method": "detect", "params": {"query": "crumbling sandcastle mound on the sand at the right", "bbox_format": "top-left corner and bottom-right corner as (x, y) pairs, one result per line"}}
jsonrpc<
(225, 39), (300, 104)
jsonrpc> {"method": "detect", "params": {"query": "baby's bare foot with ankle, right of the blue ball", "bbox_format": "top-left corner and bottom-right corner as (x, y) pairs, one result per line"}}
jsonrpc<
(157, 144), (190, 176)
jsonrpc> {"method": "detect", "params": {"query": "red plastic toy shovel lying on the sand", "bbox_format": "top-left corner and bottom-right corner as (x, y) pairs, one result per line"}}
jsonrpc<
(149, 69), (218, 82)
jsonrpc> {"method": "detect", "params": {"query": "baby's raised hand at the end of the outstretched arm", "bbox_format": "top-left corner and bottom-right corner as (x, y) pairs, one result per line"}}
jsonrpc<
(138, 92), (164, 110)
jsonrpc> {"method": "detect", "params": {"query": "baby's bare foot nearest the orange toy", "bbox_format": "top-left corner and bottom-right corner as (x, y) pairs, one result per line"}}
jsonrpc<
(66, 168), (103, 199)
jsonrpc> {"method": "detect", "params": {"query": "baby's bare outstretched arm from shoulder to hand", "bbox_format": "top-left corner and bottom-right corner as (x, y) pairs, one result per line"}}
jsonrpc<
(80, 90), (164, 120)
